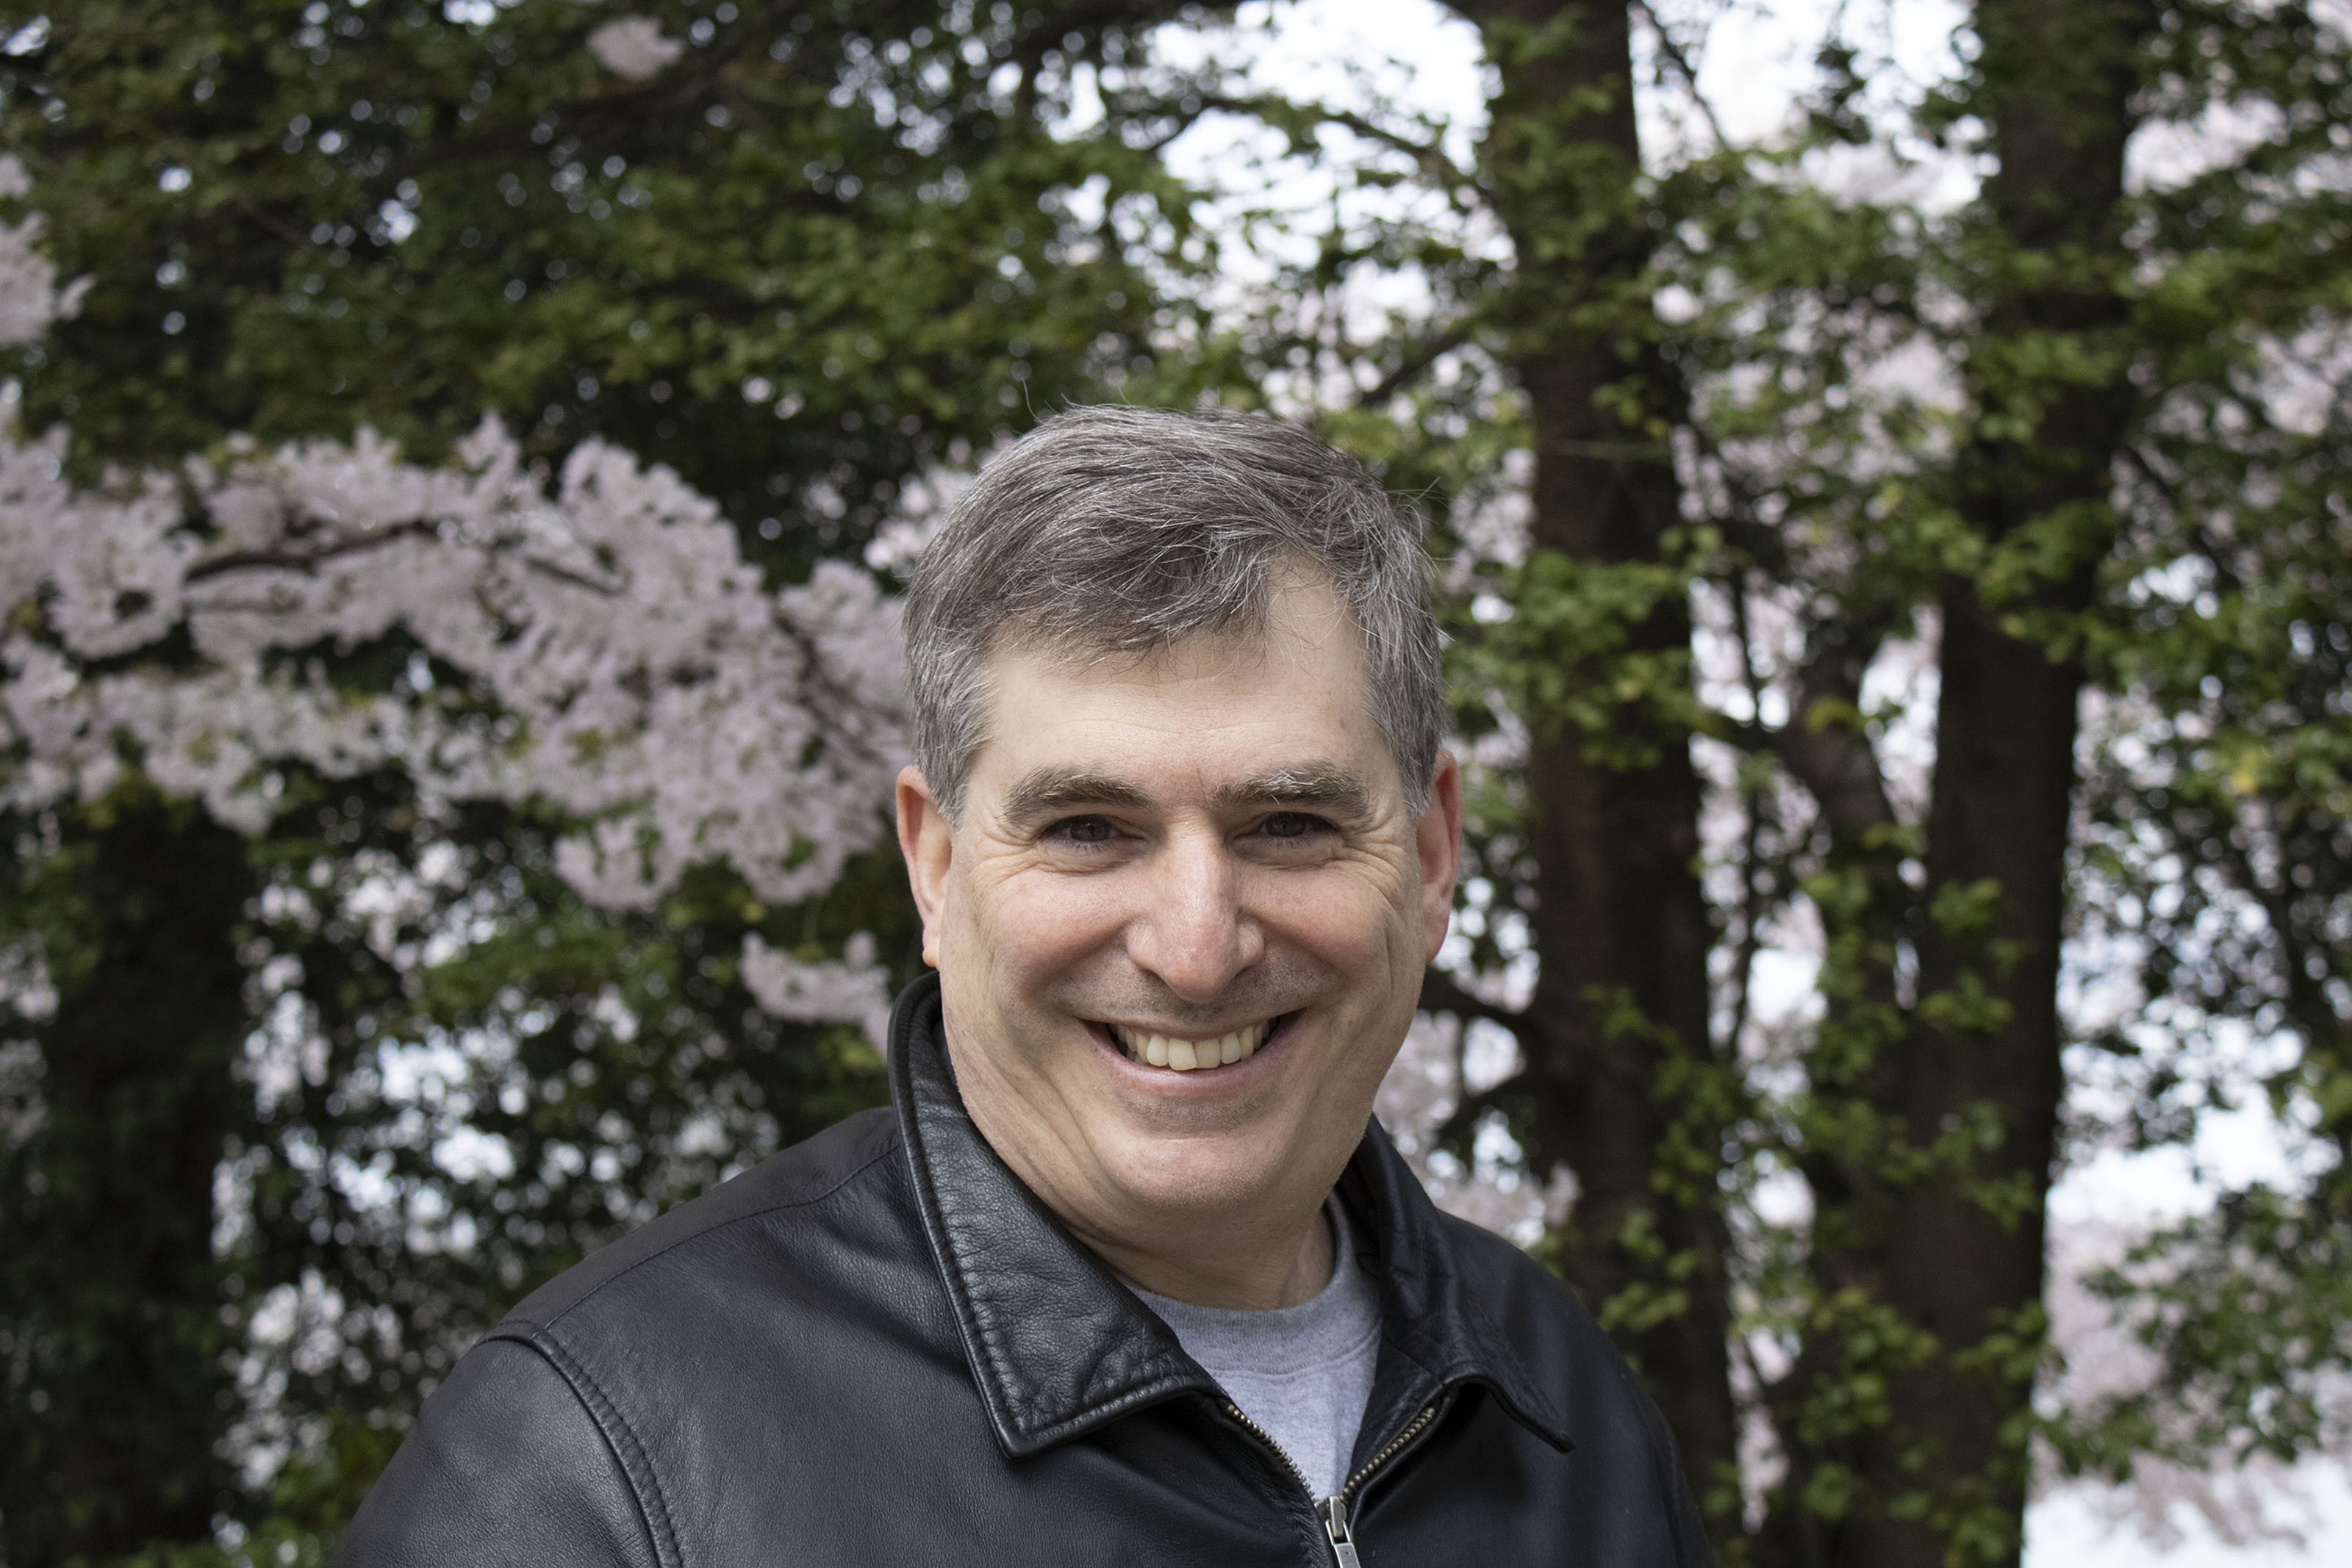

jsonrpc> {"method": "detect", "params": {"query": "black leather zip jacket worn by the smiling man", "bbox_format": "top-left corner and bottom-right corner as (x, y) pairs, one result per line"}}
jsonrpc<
(337, 980), (1707, 1568)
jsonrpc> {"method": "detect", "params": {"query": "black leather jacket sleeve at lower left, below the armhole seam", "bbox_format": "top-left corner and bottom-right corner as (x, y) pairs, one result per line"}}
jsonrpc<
(334, 1337), (675, 1568)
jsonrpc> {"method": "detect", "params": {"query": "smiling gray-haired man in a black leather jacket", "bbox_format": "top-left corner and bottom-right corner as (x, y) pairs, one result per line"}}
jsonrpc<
(339, 409), (1707, 1568)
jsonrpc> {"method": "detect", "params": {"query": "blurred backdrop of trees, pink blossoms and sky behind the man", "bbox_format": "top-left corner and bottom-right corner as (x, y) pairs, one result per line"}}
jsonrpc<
(0, 0), (2352, 1568)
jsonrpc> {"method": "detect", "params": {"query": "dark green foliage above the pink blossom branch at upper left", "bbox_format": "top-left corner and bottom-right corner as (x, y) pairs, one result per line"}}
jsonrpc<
(0, 0), (1186, 552)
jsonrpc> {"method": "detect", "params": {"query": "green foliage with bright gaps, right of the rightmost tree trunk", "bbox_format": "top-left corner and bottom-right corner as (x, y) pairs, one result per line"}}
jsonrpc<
(2082, 4), (2352, 1486)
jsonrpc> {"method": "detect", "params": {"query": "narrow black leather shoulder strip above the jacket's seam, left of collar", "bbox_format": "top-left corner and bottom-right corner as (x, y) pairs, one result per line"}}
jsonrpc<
(503, 1107), (898, 1328)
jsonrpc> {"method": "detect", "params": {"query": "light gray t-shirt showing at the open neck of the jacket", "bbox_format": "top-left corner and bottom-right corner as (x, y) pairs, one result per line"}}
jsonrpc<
(1136, 1201), (1380, 1497)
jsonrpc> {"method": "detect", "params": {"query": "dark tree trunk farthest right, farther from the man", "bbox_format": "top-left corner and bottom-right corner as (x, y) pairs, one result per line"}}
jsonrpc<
(1837, 0), (2154, 1568)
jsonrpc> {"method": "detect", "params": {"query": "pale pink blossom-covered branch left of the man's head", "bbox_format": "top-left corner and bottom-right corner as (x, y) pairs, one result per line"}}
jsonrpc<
(0, 169), (903, 1023)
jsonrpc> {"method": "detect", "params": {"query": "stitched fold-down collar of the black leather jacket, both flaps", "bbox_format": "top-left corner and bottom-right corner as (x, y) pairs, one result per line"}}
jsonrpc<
(889, 974), (1568, 1458)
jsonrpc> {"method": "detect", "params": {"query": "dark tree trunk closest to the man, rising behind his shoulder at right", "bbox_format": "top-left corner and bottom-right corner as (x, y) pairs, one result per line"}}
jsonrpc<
(1456, 0), (1736, 1531)
